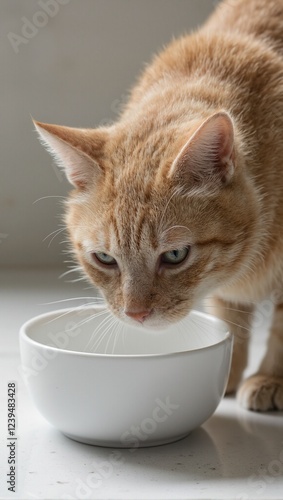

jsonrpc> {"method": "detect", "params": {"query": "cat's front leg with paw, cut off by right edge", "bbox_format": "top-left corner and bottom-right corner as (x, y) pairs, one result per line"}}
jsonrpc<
(238, 303), (283, 411)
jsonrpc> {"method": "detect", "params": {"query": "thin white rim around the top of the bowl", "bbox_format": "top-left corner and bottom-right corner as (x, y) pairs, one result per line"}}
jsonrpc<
(19, 304), (233, 360)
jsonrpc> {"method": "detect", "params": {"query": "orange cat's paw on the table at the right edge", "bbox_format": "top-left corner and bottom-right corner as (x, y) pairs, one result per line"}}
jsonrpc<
(237, 374), (283, 411)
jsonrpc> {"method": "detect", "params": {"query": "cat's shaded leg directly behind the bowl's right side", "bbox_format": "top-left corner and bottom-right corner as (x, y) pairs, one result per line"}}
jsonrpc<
(206, 297), (254, 394)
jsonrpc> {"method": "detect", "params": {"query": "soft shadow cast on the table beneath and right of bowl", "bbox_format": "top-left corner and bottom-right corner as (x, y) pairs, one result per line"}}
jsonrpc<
(58, 402), (283, 482)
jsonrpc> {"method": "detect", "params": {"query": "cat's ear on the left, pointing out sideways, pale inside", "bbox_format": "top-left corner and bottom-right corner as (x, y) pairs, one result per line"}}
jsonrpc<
(33, 121), (106, 189)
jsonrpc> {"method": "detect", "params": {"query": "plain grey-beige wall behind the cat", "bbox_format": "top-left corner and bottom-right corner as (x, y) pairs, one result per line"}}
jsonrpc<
(0, 0), (217, 266)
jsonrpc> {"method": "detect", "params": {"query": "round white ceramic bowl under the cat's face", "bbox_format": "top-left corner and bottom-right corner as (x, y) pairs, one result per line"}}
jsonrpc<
(20, 306), (232, 448)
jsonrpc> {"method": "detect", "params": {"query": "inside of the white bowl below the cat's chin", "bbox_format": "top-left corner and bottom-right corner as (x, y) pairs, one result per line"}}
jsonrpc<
(21, 306), (229, 356)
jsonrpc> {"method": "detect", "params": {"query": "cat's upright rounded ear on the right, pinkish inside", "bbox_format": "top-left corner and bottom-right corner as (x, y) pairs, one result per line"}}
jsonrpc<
(169, 111), (234, 191)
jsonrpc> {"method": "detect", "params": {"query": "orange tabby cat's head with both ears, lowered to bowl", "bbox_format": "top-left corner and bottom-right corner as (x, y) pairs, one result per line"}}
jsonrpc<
(35, 111), (257, 328)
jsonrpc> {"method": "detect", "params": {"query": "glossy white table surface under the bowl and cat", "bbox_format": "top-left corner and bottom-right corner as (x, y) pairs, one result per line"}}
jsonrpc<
(0, 269), (283, 500)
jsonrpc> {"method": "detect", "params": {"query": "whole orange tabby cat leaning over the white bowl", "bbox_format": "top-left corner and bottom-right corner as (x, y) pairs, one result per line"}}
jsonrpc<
(35, 0), (283, 411)
